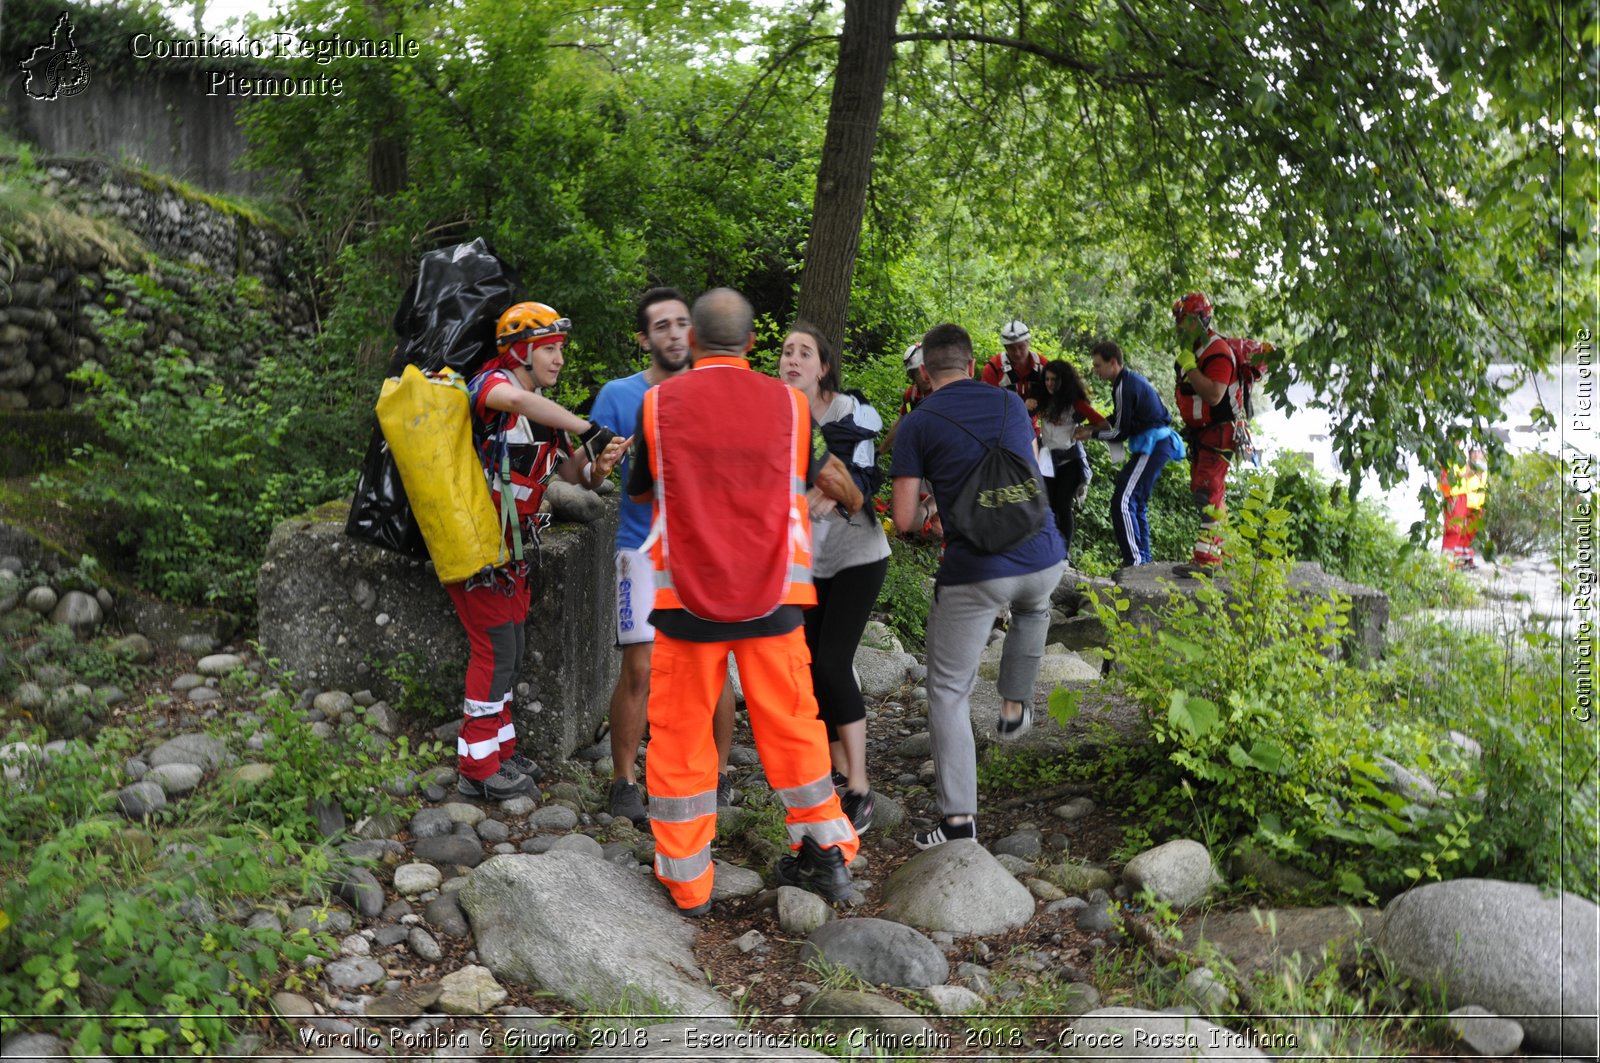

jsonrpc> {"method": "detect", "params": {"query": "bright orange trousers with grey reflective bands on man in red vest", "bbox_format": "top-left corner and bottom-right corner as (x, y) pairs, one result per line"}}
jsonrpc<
(645, 628), (861, 908)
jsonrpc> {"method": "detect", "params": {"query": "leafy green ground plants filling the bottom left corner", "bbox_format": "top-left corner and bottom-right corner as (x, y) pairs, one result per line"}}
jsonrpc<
(0, 726), (324, 1057)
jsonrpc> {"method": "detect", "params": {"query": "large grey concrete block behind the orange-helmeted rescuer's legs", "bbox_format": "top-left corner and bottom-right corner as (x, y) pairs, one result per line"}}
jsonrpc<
(256, 498), (621, 760)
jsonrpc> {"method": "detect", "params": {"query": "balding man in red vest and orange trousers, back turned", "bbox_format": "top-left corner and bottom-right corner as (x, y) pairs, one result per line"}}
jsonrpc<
(627, 288), (861, 916)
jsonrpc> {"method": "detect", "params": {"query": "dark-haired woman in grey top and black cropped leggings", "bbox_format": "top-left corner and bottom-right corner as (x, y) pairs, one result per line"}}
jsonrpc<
(778, 322), (890, 832)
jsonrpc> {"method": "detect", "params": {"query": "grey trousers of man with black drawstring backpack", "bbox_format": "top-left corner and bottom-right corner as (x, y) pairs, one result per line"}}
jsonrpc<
(926, 562), (1066, 816)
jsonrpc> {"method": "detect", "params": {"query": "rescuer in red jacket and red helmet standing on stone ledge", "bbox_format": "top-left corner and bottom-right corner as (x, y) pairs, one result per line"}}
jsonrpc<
(1173, 291), (1245, 575)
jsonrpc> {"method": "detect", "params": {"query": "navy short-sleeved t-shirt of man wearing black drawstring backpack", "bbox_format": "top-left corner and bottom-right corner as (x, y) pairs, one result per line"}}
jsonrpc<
(890, 379), (1067, 584)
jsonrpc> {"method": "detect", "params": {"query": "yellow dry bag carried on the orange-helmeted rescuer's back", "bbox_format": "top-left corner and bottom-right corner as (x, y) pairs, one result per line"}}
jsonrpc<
(378, 365), (506, 583)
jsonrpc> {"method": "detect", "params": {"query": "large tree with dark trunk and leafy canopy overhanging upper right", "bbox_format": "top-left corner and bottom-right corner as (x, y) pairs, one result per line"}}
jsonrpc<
(778, 0), (1597, 483)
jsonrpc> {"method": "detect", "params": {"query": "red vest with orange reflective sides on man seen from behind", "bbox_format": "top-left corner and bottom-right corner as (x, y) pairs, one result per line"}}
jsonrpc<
(640, 357), (816, 623)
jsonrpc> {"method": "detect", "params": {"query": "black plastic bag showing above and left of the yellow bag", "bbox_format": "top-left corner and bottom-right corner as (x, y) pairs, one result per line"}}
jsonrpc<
(344, 239), (520, 559)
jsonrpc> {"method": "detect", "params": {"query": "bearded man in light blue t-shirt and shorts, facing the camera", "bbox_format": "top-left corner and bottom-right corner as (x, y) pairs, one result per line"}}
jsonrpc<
(589, 288), (733, 826)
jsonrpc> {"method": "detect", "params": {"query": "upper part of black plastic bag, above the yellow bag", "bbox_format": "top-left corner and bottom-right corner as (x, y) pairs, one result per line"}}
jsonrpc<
(395, 237), (522, 376)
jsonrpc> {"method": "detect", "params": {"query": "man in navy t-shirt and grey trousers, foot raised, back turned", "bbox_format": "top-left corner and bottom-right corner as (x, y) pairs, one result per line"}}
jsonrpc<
(890, 325), (1066, 848)
